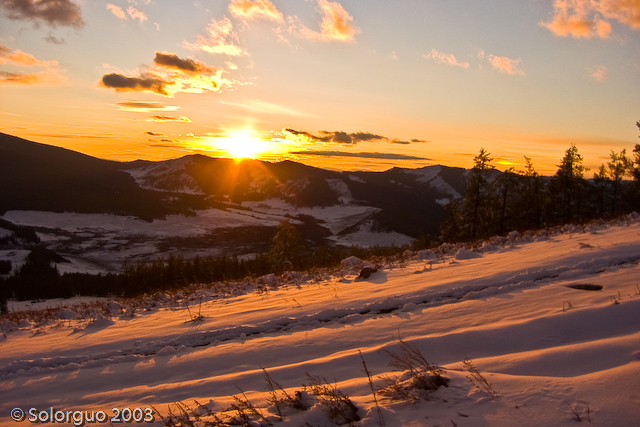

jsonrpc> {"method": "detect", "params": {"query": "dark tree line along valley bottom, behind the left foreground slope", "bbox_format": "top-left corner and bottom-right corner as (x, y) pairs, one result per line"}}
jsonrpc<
(0, 219), (398, 313)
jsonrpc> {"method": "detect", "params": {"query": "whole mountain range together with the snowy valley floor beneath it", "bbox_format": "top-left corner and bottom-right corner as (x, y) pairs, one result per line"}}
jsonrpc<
(0, 134), (467, 270)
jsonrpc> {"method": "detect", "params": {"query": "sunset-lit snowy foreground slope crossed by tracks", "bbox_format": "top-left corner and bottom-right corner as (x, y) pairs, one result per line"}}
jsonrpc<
(0, 218), (640, 427)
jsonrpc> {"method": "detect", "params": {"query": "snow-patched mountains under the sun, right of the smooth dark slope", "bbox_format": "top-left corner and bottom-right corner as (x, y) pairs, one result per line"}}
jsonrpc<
(126, 155), (466, 237)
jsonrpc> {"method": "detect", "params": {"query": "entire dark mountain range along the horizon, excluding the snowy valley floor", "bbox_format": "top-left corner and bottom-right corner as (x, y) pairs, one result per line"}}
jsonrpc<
(0, 134), (466, 241)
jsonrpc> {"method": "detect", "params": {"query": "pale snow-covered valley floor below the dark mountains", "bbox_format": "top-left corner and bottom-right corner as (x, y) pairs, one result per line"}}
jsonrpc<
(1, 201), (412, 274)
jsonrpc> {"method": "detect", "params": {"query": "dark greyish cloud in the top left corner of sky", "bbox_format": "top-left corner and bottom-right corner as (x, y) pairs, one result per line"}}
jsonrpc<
(0, 0), (84, 28)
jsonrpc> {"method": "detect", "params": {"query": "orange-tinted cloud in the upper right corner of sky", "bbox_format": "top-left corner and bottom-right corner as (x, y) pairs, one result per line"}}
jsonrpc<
(540, 0), (640, 38)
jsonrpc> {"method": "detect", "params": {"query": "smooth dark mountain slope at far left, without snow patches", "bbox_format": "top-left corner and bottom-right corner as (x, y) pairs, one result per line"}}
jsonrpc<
(0, 133), (188, 220)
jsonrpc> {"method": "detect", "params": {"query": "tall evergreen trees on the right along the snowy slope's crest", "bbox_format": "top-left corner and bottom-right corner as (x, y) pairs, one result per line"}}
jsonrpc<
(440, 121), (640, 242)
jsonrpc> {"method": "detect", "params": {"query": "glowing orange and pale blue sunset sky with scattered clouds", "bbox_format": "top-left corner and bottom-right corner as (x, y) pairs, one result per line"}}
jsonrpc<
(0, 0), (640, 174)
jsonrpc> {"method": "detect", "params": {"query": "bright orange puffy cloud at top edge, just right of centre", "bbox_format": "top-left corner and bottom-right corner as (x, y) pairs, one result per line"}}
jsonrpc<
(288, 0), (361, 42)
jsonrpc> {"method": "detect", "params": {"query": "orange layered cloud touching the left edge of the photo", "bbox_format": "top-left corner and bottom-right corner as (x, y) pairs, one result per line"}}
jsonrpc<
(0, 45), (64, 85)
